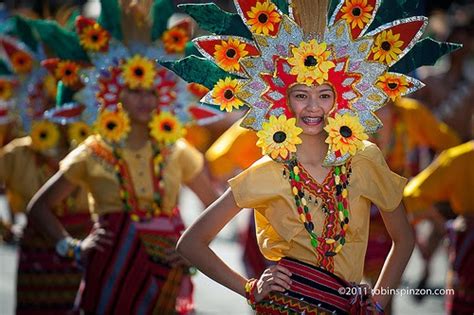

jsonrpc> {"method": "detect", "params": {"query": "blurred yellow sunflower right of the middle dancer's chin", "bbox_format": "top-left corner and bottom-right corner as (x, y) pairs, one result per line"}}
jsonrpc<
(148, 111), (186, 144)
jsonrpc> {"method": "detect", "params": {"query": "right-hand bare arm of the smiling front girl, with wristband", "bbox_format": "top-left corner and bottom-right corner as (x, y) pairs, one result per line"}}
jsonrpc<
(374, 203), (415, 307)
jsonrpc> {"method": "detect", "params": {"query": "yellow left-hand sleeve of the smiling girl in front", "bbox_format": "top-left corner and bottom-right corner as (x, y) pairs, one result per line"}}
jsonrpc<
(228, 157), (279, 209)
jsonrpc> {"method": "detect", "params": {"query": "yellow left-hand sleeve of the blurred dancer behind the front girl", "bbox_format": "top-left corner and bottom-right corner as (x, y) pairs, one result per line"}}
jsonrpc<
(59, 144), (89, 186)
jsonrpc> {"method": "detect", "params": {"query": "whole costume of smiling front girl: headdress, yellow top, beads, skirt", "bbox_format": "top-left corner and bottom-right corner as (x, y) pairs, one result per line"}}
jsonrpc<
(166, 0), (457, 314)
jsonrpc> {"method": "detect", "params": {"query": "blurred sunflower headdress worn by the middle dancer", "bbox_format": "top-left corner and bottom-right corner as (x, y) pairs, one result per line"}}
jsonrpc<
(29, 0), (221, 144)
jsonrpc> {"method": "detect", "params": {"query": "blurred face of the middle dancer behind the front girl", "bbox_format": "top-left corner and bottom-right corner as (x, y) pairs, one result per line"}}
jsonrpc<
(120, 89), (158, 124)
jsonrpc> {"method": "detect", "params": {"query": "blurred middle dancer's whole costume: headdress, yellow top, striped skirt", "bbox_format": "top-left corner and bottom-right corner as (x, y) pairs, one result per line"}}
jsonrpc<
(27, 0), (222, 314)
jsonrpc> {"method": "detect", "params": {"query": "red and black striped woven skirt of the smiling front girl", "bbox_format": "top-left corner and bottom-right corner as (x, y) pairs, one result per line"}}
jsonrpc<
(256, 258), (374, 315)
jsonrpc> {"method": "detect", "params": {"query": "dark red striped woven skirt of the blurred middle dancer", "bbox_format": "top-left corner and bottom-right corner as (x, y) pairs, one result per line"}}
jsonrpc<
(77, 210), (194, 315)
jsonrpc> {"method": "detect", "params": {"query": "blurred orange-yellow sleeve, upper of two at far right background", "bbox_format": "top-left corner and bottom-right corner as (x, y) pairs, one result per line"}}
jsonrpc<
(401, 98), (461, 151)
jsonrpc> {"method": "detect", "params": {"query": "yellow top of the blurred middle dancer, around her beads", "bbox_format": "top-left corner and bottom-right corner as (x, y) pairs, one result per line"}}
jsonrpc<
(60, 135), (204, 215)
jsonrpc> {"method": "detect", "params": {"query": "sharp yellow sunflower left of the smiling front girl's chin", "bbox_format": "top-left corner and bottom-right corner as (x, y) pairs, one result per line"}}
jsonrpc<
(257, 115), (303, 159)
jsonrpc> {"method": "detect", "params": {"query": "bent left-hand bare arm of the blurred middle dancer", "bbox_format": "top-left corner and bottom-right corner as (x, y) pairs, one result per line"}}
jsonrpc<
(28, 171), (77, 242)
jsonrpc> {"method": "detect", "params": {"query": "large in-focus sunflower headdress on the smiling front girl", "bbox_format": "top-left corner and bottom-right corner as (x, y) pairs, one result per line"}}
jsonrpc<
(162, 0), (459, 165)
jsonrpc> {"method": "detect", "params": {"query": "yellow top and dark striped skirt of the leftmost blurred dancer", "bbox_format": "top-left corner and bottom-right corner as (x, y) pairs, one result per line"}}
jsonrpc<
(0, 137), (92, 314)
